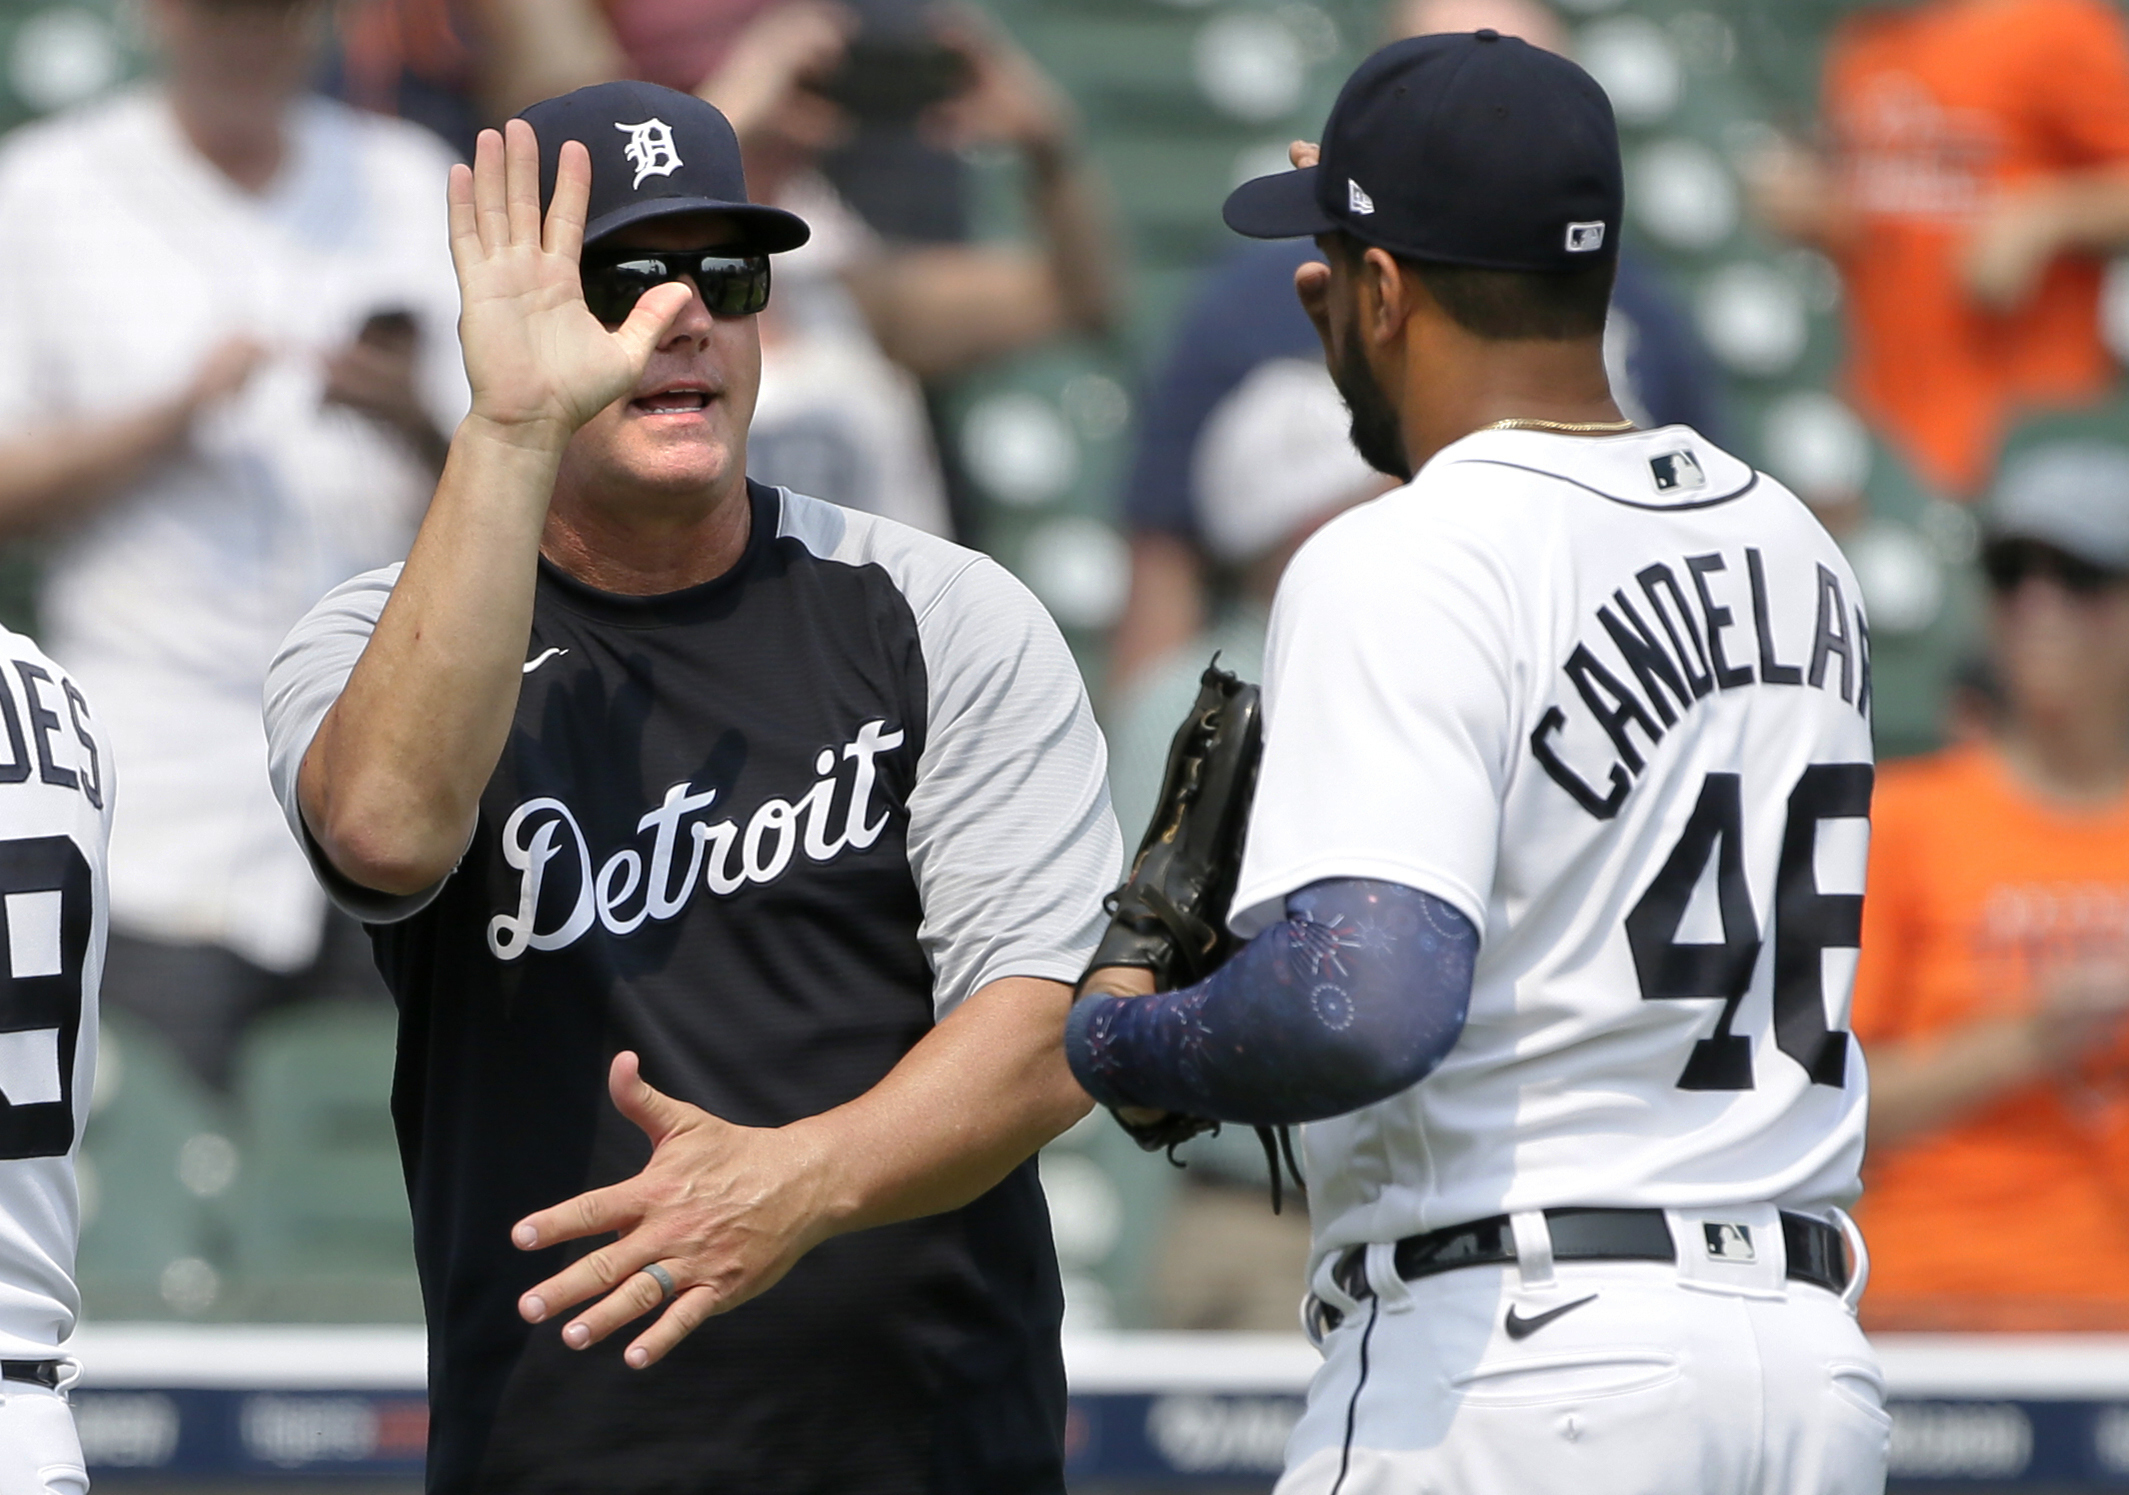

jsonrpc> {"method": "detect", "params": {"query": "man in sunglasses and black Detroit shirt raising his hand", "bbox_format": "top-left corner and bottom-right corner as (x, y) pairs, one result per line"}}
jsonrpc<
(266, 83), (1120, 1495)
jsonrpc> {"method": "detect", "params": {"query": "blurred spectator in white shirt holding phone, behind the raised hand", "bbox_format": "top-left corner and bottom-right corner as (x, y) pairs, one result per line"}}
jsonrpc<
(0, 0), (464, 1086)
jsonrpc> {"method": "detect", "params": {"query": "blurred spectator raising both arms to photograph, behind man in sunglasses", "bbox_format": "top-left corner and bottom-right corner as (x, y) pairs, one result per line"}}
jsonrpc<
(700, 0), (1118, 530)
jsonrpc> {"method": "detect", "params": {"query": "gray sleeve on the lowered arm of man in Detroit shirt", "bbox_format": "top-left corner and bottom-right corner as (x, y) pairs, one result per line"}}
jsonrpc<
(909, 560), (1124, 1018)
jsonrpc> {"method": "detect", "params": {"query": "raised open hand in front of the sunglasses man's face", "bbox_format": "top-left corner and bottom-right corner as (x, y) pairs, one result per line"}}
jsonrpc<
(451, 119), (690, 447)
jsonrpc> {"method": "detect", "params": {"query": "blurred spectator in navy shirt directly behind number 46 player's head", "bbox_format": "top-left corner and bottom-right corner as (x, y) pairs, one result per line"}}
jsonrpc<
(1109, 0), (1722, 688)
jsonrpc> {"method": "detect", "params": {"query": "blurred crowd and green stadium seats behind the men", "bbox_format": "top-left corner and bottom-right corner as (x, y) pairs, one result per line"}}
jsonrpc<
(12, 0), (2129, 1329)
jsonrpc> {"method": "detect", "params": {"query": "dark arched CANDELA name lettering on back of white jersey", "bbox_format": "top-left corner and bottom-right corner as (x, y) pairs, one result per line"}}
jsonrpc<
(1531, 547), (1869, 820)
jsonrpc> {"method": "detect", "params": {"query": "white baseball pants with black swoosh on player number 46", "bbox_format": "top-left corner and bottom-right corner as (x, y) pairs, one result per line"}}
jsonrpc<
(1275, 1208), (1893, 1495)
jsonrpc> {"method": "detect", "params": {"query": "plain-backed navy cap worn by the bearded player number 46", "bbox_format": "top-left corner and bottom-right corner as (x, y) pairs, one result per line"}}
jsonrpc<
(1222, 30), (1624, 270)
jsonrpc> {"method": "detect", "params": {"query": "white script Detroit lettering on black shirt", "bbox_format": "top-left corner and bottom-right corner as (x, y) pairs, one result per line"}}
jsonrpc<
(488, 720), (903, 960)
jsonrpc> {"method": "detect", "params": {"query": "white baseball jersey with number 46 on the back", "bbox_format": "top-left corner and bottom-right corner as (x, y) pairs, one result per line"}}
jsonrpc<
(1235, 426), (1871, 1256)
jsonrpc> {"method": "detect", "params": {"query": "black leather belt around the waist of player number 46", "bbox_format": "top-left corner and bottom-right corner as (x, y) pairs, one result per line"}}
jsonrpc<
(1324, 1210), (1848, 1323)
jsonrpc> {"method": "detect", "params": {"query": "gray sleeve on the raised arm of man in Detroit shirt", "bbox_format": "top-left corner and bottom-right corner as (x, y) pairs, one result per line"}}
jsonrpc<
(266, 566), (443, 924)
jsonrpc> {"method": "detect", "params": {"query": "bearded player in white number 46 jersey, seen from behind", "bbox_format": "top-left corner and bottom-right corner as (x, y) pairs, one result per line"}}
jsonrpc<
(1067, 32), (1888, 1495)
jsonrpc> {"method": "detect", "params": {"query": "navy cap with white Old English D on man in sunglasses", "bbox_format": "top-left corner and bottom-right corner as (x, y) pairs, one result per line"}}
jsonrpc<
(519, 83), (813, 253)
